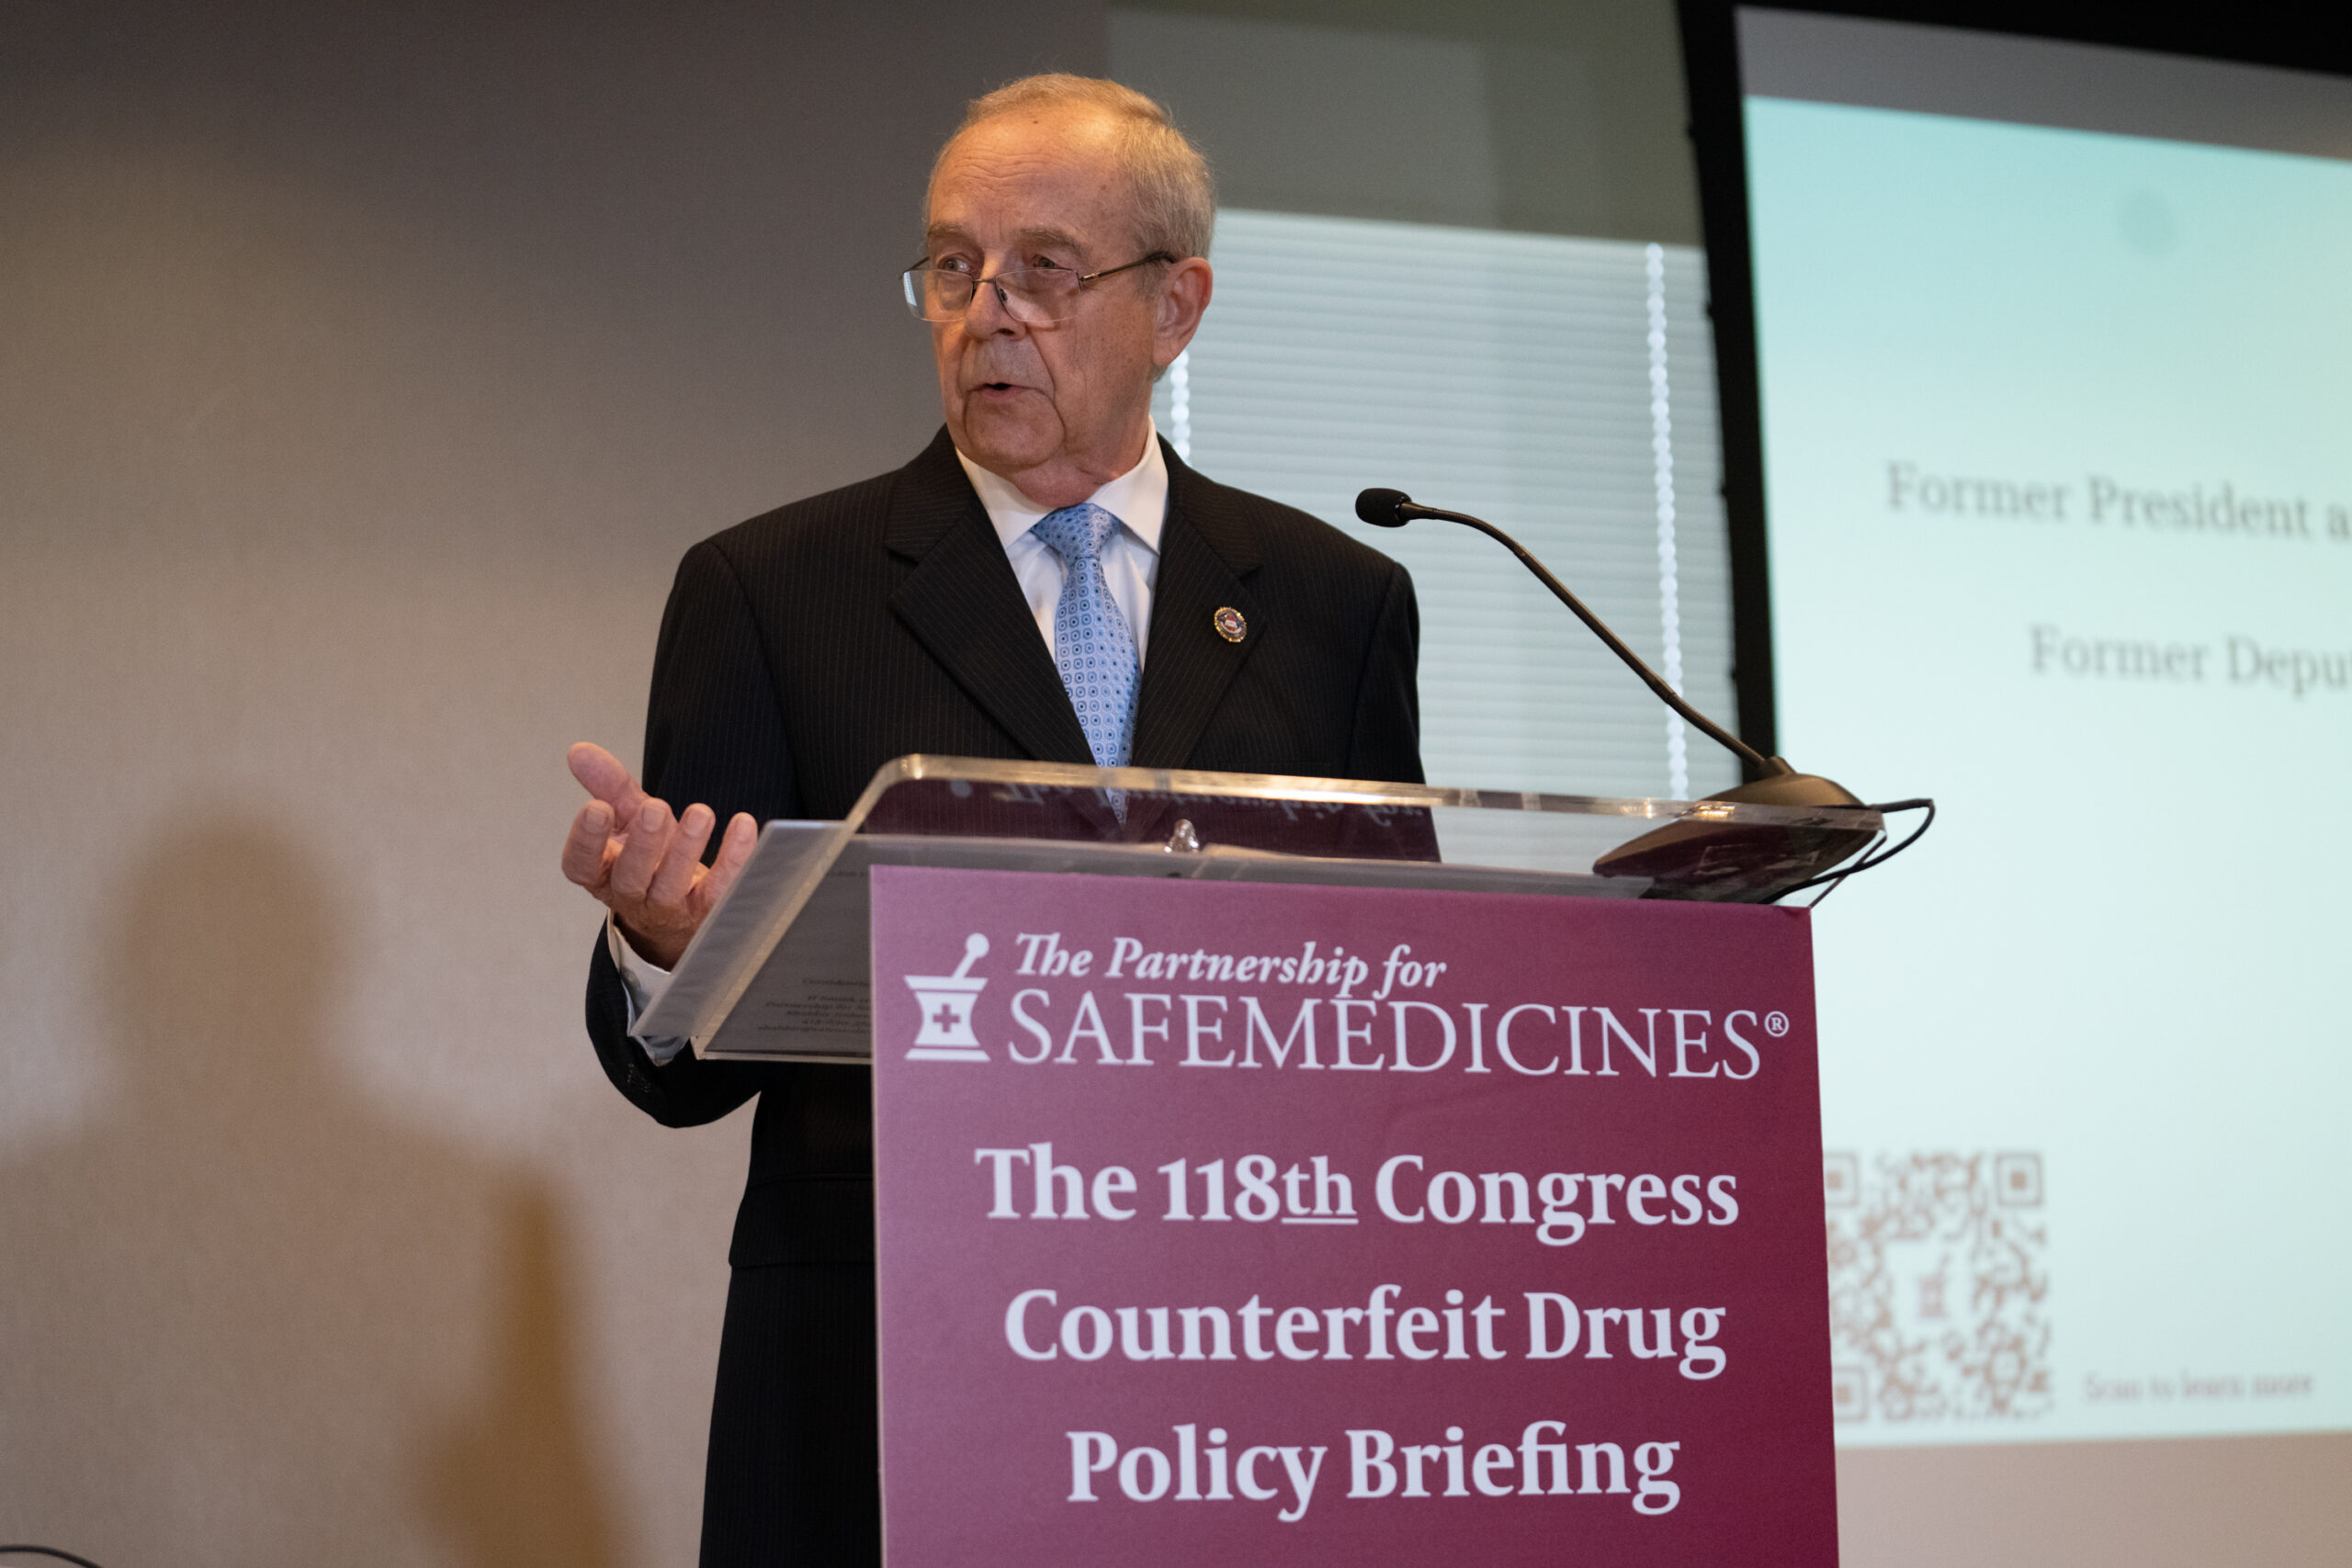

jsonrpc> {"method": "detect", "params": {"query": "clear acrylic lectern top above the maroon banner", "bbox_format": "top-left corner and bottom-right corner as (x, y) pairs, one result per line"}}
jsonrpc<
(633, 755), (1882, 1063)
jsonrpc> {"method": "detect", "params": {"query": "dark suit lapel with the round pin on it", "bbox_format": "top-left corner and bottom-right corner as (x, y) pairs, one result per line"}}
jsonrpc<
(1124, 442), (1265, 769)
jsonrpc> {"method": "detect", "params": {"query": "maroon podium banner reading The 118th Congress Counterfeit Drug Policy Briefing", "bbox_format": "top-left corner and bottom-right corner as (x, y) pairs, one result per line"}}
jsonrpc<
(873, 867), (1837, 1568)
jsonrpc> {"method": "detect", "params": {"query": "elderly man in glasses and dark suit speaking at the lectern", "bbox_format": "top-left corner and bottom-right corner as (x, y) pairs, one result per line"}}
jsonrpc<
(564, 75), (1420, 1563)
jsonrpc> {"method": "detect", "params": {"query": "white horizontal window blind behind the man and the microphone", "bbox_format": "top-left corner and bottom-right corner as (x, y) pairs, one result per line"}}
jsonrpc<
(1152, 209), (1738, 797)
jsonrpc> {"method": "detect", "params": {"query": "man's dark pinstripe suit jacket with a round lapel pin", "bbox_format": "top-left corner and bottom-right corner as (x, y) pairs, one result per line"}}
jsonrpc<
(588, 430), (1420, 1267)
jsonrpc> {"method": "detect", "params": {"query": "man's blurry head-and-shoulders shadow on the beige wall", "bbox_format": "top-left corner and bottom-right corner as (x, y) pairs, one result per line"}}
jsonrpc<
(0, 811), (616, 1568)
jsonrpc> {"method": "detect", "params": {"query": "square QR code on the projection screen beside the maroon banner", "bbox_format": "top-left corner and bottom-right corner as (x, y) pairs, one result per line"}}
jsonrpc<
(1823, 1152), (2051, 1422)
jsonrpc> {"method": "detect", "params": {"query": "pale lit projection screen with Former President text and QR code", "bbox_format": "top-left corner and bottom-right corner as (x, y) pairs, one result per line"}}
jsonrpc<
(1736, 9), (2352, 1476)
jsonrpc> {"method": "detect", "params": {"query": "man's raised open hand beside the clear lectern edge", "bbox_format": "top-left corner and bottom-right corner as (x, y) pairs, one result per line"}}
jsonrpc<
(564, 740), (760, 968)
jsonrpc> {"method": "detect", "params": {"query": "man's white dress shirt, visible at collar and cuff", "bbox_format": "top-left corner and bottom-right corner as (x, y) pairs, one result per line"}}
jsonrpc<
(605, 423), (1169, 1063)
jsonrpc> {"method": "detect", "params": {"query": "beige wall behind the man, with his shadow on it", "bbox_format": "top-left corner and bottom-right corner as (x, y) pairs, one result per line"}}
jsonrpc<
(0, 0), (2352, 1568)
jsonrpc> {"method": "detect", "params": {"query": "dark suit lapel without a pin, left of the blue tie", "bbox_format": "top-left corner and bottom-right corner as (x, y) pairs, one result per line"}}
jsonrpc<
(885, 430), (1095, 761)
